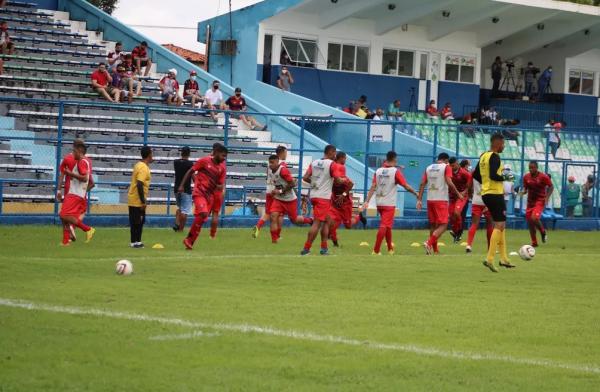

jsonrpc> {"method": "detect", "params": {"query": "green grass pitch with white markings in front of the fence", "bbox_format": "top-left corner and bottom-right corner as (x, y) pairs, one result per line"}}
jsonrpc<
(0, 226), (600, 392)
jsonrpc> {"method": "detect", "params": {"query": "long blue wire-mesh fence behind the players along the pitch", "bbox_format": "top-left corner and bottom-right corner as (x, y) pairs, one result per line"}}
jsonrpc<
(0, 97), (600, 224)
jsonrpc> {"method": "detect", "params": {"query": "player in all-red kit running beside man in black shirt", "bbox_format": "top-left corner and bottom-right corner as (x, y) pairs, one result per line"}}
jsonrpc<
(178, 144), (227, 250)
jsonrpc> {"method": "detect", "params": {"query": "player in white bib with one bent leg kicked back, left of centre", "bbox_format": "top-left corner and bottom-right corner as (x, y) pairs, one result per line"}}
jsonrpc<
(268, 155), (313, 244)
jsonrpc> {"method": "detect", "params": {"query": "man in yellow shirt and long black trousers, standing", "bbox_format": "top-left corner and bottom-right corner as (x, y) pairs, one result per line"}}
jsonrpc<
(127, 146), (152, 248)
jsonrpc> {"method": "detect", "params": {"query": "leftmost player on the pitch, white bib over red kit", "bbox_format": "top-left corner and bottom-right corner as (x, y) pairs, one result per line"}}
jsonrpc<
(60, 144), (96, 246)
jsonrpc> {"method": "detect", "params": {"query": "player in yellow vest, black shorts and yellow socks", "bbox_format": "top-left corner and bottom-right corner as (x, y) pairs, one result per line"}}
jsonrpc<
(473, 133), (515, 272)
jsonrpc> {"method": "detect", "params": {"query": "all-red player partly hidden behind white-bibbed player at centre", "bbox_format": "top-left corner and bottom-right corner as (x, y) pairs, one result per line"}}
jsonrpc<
(329, 151), (367, 247)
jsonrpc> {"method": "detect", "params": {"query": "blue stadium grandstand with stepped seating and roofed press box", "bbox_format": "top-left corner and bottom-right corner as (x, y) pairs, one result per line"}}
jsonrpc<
(0, 0), (600, 229)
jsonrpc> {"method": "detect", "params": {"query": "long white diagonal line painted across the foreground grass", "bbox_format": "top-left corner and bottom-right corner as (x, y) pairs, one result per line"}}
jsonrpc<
(0, 298), (600, 374)
